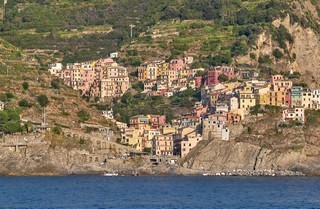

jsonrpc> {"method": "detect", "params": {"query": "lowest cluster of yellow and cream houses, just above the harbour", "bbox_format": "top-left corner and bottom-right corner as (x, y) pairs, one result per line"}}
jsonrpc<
(121, 112), (202, 156)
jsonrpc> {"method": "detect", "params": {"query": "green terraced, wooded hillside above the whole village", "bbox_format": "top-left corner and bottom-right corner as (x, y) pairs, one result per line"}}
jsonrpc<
(0, 0), (320, 66)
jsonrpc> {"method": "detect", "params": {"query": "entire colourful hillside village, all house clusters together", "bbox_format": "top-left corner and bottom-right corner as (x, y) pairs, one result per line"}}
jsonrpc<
(49, 54), (320, 157)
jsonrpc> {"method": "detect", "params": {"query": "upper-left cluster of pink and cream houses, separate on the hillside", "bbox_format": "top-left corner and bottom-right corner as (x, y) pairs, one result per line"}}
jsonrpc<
(48, 58), (131, 98)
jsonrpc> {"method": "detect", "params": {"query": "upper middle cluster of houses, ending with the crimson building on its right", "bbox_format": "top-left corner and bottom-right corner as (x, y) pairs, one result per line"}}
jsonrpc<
(137, 56), (236, 97)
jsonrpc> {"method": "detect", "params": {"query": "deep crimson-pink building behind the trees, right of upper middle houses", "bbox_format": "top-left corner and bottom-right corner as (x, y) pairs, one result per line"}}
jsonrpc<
(206, 66), (235, 86)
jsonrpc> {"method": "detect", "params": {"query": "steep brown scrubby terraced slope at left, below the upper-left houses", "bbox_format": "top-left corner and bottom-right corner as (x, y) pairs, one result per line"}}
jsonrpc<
(0, 39), (112, 131)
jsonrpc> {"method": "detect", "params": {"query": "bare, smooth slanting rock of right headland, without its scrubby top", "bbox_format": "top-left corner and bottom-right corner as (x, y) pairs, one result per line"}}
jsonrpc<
(182, 139), (320, 175)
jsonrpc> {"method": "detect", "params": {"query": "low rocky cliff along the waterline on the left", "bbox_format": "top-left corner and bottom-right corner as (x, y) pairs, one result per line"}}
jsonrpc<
(0, 144), (177, 176)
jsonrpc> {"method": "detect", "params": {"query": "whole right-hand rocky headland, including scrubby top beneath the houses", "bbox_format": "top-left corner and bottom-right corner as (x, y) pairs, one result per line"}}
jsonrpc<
(181, 115), (320, 175)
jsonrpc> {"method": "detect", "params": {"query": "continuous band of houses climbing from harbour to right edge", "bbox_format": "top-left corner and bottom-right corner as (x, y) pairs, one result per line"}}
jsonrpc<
(116, 70), (320, 157)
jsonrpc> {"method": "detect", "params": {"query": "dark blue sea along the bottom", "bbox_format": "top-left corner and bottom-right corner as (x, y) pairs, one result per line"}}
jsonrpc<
(0, 176), (320, 209)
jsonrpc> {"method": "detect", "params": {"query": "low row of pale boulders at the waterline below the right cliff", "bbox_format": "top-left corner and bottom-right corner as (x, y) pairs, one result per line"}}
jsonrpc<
(203, 169), (305, 176)
